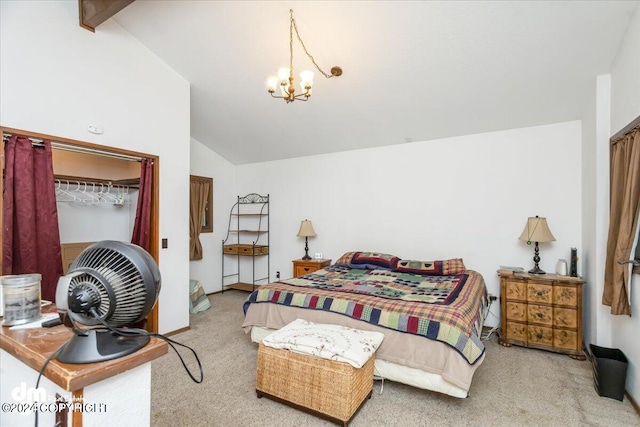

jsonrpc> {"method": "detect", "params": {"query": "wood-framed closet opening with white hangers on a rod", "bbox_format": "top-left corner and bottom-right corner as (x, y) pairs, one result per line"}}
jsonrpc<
(0, 127), (159, 332)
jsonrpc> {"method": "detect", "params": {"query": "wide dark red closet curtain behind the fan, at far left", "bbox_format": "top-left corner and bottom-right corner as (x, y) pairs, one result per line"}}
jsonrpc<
(2, 135), (62, 301)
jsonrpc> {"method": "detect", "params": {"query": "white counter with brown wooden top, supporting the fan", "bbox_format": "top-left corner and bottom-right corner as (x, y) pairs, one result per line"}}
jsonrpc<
(0, 307), (168, 427)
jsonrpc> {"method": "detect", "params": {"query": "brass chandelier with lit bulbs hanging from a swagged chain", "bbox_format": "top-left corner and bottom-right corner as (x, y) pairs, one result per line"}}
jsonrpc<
(267, 9), (342, 104)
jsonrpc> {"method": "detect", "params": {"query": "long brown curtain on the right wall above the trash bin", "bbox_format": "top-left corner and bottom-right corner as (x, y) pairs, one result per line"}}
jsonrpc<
(602, 127), (640, 315)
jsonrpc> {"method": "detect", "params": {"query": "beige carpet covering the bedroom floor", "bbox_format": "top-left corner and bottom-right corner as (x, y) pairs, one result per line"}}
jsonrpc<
(151, 291), (640, 427)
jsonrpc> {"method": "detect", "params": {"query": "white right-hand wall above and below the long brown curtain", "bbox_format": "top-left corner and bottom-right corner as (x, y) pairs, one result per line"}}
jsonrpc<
(606, 9), (640, 402)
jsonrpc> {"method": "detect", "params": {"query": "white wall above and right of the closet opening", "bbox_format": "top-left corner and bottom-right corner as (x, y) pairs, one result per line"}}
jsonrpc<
(0, 1), (190, 332)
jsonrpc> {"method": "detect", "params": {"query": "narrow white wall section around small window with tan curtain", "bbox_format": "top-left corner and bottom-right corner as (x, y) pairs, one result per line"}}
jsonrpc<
(189, 138), (237, 293)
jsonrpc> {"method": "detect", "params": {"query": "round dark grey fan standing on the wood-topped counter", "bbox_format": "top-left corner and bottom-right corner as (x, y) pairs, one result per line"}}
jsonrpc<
(56, 240), (161, 363)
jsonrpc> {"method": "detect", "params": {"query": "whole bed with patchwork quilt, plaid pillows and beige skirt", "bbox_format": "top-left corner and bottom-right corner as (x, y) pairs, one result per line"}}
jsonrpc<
(242, 252), (487, 398)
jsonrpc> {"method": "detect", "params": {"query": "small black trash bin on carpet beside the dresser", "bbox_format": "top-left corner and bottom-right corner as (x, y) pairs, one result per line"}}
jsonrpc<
(589, 344), (629, 401)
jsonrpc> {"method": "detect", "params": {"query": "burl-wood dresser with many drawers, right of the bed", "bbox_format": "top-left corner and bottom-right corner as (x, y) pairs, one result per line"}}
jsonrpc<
(498, 271), (585, 360)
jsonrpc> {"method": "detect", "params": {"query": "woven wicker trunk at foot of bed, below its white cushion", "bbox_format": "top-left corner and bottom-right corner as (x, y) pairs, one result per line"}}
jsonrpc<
(256, 343), (375, 426)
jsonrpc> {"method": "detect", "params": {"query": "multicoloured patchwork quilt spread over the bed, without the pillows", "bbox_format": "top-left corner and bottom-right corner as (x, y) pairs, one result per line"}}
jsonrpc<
(244, 265), (486, 364)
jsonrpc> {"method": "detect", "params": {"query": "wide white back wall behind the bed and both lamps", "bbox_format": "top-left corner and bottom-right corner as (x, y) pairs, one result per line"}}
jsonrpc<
(237, 122), (582, 324)
